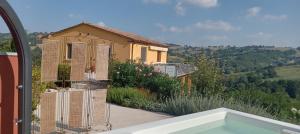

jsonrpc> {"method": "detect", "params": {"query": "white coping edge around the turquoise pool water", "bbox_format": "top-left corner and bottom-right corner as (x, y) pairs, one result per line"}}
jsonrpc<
(100, 108), (300, 134)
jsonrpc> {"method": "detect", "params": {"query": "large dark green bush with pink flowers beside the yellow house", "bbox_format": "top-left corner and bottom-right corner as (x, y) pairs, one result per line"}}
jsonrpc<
(110, 61), (181, 98)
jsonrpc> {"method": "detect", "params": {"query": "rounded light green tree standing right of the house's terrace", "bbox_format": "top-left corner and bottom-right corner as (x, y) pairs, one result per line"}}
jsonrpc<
(192, 54), (224, 96)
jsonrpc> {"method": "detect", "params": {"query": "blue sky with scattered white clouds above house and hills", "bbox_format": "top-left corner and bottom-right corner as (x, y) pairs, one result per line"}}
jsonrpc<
(2, 0), (300, 47)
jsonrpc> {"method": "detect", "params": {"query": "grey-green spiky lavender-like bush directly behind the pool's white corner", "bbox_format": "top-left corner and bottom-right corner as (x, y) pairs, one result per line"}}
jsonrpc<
(161, 96), (276, 119)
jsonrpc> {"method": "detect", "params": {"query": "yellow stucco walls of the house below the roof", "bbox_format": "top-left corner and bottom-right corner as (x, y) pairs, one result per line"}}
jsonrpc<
(43, 25), (167, 64)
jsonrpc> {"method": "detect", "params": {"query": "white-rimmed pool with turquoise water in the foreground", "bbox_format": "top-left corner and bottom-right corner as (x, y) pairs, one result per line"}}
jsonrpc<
(103, 108), (300, 134)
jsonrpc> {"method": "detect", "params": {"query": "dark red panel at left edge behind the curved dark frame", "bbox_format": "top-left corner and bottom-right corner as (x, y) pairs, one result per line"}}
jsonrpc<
(0, 55), (18, 134)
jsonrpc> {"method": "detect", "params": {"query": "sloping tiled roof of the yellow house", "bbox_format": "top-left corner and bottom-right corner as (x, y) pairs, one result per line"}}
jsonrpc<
(43, 22), (169, 47)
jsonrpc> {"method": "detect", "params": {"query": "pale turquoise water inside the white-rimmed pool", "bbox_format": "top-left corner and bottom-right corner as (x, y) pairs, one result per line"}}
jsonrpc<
(172, 119), (280, 134)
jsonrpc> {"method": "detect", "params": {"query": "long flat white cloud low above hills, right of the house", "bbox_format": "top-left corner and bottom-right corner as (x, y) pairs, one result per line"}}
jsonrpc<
(196, 20), (240, 32)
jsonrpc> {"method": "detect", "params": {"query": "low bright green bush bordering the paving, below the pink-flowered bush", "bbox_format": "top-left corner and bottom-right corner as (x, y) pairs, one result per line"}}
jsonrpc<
(107, 88), (161, 111)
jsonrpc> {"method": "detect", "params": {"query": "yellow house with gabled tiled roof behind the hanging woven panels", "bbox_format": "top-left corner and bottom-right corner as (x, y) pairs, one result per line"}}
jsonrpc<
(42, 23), (168, 66)
